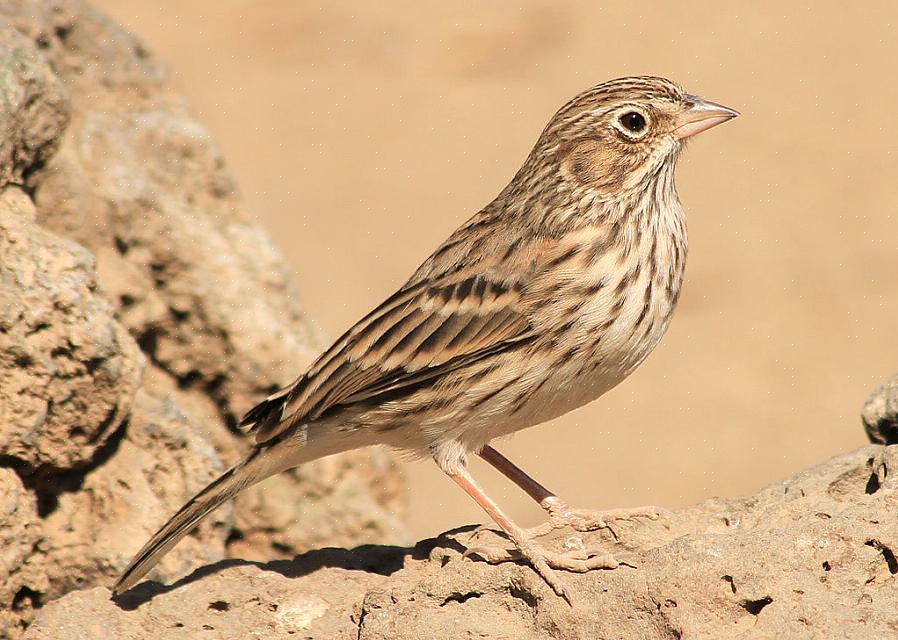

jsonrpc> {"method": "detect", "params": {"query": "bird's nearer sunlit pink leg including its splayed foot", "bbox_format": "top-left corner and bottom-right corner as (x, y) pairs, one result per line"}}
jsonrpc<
(440, 461), (620, 603)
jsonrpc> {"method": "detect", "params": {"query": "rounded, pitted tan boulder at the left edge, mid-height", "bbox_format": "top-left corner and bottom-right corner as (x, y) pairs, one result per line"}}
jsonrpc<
(0, 187), (143, 472)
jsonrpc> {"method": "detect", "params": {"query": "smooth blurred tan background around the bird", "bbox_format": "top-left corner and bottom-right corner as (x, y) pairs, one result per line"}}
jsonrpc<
(96, 0), (898, 536)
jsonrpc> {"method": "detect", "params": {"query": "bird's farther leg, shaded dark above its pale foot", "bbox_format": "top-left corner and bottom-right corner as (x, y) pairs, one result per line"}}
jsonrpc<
(480, 446), (662, 538)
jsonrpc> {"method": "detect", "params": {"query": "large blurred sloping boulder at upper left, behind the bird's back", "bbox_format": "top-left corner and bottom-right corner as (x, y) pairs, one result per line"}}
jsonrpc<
(17, 2), (319, 425)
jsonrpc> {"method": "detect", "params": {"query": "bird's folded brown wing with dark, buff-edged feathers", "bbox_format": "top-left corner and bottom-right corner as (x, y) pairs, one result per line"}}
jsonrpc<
(241, 236), (532, 444)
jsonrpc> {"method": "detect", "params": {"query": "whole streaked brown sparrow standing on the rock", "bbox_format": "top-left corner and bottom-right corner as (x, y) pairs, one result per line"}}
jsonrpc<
(113, 76), (739, 602)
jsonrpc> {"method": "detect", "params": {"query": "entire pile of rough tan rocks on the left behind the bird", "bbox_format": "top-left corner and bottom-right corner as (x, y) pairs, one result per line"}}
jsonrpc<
(0, 0), (404, 638)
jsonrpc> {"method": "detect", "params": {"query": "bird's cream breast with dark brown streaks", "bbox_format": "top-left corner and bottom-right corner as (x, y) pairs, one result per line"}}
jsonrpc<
(524, 206), (686, 413)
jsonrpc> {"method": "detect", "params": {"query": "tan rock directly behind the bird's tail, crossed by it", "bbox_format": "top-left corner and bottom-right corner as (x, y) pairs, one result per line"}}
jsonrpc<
(37, 388), (232, 594)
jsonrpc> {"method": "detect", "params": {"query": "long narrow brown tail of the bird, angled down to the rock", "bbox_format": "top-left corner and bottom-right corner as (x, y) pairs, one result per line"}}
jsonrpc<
(112, 449), (282, 595)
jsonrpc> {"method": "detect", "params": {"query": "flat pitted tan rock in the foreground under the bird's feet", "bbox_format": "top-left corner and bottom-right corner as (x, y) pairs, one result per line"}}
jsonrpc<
(25, 445), (898, 640)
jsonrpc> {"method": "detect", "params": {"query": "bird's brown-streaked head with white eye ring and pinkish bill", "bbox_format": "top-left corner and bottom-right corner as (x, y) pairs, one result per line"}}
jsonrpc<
(534, 76), (739, 199)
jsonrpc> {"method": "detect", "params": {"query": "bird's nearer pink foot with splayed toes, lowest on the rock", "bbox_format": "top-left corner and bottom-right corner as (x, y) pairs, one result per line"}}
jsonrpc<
(462, 540), (636, 604)
